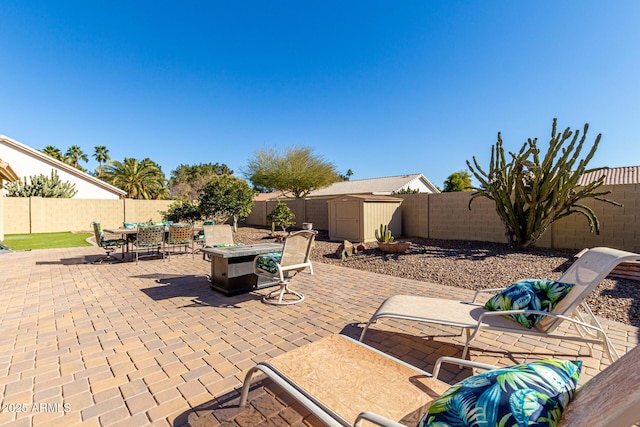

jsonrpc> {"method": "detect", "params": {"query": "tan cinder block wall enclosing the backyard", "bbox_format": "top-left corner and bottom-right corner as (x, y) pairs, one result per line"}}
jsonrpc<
(3, 184), (640, 252)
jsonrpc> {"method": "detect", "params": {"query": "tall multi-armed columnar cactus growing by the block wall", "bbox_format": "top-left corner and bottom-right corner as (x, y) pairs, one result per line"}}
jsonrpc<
(467, 119), (621, 249)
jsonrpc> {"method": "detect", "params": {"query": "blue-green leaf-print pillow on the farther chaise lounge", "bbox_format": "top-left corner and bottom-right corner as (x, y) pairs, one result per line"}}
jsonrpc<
(484, 279), (573, 329)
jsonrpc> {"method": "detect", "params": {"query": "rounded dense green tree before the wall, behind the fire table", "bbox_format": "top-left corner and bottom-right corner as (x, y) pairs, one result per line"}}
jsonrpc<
(198, 175), (254, 229)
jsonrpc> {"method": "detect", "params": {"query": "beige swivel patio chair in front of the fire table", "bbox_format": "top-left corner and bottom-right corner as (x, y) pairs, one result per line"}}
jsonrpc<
(253, 230), (318, 305)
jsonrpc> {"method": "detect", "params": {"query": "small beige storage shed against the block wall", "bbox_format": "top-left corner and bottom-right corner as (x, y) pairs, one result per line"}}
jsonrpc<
(328, 194), (402, 243)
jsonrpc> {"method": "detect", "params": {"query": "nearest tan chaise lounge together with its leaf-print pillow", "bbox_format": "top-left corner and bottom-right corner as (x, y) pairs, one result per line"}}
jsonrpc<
(240, 335), (640, 427)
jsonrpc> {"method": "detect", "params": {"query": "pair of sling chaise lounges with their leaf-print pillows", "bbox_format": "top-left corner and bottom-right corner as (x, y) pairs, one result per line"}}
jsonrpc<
(240, 248), (640, 427)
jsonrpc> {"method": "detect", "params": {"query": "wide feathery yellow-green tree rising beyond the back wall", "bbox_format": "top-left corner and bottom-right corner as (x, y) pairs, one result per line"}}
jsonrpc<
(245, 147), (341, 199)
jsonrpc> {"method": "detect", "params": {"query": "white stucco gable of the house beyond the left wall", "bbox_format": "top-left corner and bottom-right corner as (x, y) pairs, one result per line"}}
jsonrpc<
(0, 135), (126, 199)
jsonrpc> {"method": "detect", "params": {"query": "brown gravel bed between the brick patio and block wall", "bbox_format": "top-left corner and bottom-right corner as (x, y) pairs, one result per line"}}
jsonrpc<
(235, 227), (640, 327)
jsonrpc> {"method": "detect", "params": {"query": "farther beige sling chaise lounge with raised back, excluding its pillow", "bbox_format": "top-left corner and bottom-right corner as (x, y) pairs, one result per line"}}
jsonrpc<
(360, 247), (640, 361)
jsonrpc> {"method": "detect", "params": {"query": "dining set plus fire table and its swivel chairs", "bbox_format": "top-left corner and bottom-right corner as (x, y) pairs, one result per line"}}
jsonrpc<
(92, 222), (317, 305)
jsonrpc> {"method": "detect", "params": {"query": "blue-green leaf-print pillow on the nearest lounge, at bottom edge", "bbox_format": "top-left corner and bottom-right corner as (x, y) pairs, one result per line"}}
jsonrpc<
(418, 360), (582, 427)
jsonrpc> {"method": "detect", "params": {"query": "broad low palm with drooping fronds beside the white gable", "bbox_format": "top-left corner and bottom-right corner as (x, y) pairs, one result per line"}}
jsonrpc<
(105, 158), (168, 200)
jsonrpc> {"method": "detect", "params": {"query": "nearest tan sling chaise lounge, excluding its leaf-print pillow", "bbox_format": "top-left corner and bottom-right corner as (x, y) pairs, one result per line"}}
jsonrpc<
(240, 335), (640, 427)
